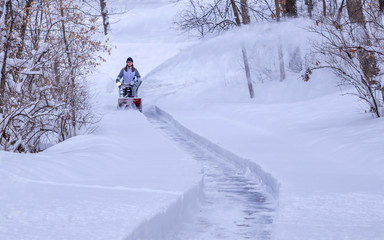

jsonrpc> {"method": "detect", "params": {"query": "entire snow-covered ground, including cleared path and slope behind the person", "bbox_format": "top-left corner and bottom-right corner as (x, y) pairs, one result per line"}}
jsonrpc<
(0, 0), (384, 240)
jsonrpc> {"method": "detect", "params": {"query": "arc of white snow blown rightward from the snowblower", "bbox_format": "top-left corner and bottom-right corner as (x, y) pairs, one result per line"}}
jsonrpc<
(143, 19), (338, 106)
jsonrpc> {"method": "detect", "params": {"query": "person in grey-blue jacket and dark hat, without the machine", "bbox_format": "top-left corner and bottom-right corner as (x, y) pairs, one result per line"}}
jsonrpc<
(116, 57), (141, 97)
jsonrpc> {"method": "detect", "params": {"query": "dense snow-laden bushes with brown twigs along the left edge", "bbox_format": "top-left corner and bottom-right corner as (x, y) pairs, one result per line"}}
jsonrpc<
(0, 0), (109, 152)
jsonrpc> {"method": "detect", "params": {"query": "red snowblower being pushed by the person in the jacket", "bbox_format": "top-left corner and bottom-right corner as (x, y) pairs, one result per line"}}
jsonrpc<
(117, 81), (143, 112)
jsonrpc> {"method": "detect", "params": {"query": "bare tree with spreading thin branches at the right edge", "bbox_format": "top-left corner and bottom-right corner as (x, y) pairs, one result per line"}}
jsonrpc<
(307, 0), (384, 117)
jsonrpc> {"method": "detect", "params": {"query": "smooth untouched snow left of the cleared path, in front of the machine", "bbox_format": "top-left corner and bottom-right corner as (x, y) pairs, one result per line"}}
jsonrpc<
(0, 111), (200, 239)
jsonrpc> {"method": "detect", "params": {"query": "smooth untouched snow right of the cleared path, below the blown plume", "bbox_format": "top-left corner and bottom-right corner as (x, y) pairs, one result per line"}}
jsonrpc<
(154, 94), (384, 239)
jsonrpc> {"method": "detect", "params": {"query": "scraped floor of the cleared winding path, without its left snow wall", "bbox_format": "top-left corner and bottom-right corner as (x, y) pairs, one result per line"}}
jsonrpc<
(145, 108), (275, 240)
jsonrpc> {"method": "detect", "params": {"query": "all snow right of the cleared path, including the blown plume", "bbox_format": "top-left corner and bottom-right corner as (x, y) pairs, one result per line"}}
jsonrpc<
(144, 13), (384, 240)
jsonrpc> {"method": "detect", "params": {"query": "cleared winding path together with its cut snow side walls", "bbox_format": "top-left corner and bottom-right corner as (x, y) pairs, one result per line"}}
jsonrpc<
(128, 107), (278, 240)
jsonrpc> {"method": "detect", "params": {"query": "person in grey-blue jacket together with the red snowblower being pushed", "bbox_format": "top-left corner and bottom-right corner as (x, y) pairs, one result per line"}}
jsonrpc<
(116, 57), (142, 112)
